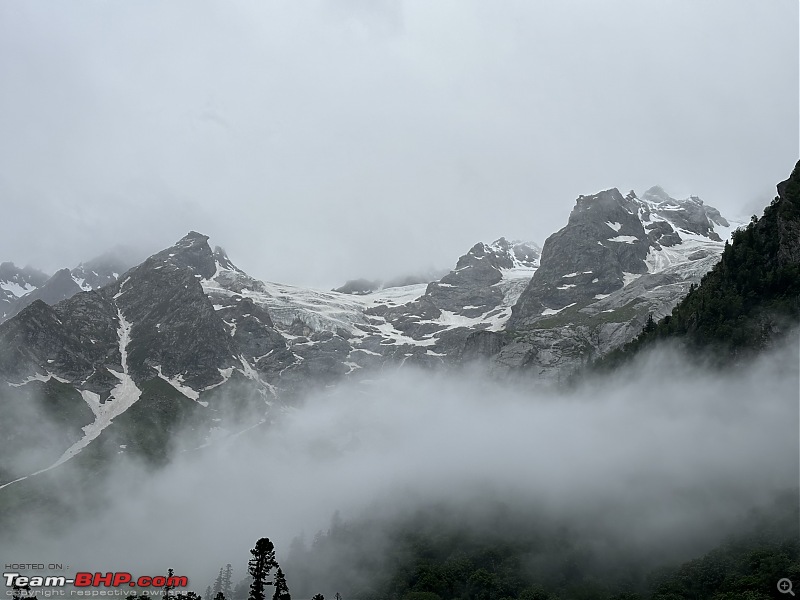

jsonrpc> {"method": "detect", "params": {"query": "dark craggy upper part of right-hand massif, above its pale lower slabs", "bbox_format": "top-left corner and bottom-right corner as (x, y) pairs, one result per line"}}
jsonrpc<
(508, 186), (730, 328)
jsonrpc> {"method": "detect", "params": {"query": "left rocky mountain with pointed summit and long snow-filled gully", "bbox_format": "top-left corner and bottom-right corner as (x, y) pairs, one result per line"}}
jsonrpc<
(0, 233), (286, 476)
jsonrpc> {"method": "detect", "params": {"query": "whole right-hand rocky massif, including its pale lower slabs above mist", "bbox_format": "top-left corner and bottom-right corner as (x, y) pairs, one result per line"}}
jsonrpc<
(478, 187), (733, 379)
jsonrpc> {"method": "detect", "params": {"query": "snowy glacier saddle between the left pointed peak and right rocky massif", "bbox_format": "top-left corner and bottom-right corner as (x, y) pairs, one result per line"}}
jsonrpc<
(203, 238), (539, 376)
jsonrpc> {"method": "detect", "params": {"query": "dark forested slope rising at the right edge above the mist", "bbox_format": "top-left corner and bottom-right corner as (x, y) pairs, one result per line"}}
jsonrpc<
(595, 162), (800, 368)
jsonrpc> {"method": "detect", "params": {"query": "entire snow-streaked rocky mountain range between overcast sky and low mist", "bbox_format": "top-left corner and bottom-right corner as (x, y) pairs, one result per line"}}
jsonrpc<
(0, 188), (731, 485)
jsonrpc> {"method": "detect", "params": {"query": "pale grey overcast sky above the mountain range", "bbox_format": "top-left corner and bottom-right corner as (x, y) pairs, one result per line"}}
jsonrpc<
(0, 0), (800, 287)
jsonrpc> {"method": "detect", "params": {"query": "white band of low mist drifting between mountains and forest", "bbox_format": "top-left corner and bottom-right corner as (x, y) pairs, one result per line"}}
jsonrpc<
(0, 343), (798, 592)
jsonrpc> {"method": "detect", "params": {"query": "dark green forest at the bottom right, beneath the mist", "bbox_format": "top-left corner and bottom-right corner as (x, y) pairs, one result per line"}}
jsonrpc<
(282, 494), (800, 600)
